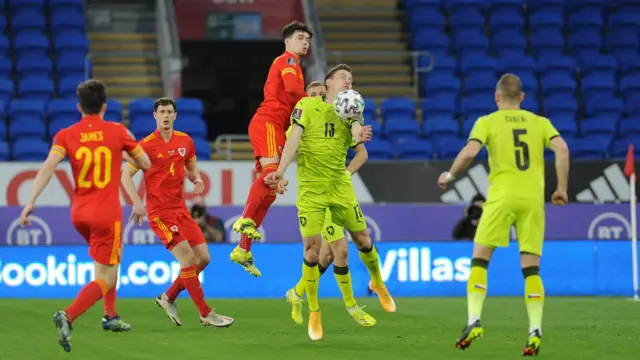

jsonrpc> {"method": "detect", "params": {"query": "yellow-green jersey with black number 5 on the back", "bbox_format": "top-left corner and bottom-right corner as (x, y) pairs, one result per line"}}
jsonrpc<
(469, 110), (560, 202)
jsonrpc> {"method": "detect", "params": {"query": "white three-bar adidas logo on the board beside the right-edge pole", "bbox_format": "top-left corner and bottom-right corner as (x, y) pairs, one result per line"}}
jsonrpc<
(576, 164), (630, 203)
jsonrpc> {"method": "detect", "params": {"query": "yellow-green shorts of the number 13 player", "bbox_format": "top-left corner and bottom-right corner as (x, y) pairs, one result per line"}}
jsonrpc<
(296, 179), (367, 241)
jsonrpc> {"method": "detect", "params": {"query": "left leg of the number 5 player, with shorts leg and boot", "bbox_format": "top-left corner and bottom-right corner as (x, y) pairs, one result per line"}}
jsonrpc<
(456, 202), (514, 350)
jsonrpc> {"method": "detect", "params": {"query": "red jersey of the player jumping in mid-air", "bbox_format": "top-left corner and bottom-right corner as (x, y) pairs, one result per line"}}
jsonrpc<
(254, 51), (306, 130)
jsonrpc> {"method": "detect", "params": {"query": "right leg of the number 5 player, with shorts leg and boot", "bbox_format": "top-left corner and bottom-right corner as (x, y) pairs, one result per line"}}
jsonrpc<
(515, 202), (545, 356)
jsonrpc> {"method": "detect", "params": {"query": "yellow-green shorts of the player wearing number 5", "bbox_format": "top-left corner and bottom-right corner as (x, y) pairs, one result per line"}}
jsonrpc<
(473, 199), (545, 255)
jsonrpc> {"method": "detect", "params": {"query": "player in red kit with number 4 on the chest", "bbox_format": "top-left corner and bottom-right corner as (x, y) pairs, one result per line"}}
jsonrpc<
(122, 97), (234, 327)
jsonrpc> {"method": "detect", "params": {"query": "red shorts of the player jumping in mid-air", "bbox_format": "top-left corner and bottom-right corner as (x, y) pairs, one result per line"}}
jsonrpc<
(249, 115), (287, 172)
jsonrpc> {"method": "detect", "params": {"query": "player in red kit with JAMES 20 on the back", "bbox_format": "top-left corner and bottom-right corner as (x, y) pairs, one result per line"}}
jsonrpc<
(20, 80), (151, 352)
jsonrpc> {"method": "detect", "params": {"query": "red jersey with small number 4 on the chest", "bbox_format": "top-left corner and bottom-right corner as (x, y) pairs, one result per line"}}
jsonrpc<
(135, 130), (196, 218)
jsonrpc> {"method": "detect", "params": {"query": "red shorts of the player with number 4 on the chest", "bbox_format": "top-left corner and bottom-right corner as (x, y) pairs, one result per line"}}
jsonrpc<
(149, 211), (206, 250)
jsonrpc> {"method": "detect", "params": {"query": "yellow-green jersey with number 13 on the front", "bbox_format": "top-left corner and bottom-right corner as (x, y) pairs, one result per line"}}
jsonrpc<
(287, 96), (357, 183)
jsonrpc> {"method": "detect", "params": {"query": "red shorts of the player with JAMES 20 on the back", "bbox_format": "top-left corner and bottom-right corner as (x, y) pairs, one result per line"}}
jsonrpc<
(73, 221), (122, 265)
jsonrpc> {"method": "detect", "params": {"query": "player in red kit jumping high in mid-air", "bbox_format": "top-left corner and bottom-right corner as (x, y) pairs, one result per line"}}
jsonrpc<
(230, 21), (313, 277)
